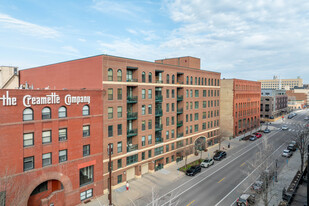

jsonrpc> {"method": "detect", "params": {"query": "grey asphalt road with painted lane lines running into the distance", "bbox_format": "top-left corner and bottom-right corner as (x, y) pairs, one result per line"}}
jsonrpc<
(145, 111), (308, 206)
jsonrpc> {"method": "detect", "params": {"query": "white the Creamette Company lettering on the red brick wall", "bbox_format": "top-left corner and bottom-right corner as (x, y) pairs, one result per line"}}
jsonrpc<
(0, 91), (91, 107)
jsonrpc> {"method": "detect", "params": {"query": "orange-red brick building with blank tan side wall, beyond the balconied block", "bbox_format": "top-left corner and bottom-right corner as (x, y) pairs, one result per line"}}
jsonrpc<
(220, 79), (261, 137)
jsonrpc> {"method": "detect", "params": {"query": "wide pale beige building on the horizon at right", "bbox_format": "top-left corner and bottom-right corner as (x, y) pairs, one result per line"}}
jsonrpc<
(258, 76), (303, 90)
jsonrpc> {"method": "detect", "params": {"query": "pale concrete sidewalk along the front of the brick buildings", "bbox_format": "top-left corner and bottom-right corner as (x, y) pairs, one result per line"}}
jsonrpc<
(81, 127), (272, 206)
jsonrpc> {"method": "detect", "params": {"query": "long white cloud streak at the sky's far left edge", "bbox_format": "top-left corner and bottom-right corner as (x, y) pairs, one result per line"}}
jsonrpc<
(0, 13), (60, 38)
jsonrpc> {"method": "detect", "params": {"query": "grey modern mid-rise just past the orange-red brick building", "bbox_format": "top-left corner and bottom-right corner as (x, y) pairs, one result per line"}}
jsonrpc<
(260, 89), (288, 119)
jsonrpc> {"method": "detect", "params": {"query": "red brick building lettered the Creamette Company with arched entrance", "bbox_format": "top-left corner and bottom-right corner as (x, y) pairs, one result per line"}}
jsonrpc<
(0, 89), (103, 206)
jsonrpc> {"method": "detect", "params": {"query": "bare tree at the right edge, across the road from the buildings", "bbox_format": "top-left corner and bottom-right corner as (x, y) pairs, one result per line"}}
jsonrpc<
(292, 124), (309, 172)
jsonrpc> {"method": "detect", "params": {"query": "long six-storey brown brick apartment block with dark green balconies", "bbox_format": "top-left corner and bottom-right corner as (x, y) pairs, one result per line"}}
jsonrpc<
(20, 55), (220, 203)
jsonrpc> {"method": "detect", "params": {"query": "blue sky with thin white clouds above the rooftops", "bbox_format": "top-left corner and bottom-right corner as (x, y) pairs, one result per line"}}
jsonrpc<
(0, 0), (309, 83)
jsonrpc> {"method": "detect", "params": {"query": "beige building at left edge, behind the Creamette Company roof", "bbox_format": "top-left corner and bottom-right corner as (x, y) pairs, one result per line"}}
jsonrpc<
(0, 66), (19, 89)
